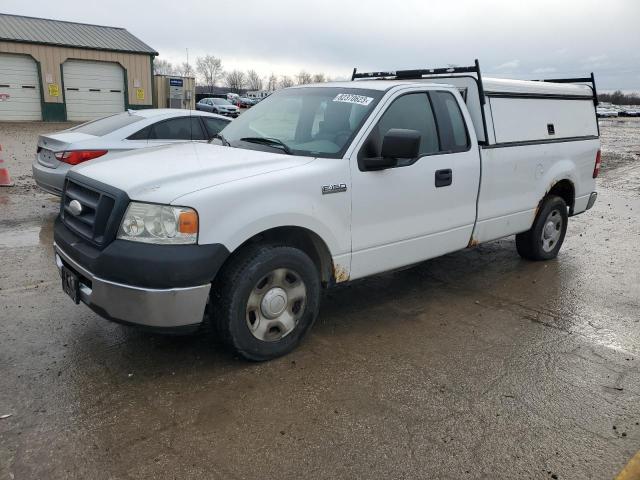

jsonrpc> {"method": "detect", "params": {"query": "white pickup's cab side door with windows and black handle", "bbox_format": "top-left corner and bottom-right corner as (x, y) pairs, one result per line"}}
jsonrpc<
(350, 90), (480, 278)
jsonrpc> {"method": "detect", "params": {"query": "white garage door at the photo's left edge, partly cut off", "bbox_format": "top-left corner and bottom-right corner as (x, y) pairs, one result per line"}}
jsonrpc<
(0, 53), (42, 121)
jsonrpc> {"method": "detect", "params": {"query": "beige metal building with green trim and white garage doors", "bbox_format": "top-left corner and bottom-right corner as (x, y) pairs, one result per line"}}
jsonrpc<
(0, 14), (158, 121)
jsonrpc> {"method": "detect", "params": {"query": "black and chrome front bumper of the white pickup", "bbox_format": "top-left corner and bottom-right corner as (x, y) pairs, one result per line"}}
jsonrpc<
(53, 217), (229, 333)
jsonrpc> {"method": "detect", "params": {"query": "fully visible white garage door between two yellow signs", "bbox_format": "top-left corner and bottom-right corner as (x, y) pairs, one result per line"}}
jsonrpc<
(62, 60), (124, 121)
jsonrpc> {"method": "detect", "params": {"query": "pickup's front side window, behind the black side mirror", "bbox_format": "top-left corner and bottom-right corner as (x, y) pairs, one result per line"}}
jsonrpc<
(372, 93), (440, 159)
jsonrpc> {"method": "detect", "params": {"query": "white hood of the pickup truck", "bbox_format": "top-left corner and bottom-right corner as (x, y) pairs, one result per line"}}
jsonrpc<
(72, 143), (314, 203)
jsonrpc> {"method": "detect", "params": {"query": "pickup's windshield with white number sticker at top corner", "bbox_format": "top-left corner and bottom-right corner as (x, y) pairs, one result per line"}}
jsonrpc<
(222, 87), (384, 158)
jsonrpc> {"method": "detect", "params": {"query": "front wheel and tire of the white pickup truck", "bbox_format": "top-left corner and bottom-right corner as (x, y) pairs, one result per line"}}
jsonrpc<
(210, 245), (321, 361)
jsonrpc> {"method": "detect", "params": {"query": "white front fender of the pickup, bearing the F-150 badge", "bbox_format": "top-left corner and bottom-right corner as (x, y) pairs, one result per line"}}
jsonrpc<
(179, 163), (351, 259)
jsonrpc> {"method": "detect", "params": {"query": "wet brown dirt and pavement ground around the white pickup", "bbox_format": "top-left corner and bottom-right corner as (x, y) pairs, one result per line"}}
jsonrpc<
(0, 119), (640, 480)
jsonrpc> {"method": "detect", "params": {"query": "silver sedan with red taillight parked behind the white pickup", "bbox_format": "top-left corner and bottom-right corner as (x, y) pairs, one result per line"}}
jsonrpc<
(32, 108), (231, 195)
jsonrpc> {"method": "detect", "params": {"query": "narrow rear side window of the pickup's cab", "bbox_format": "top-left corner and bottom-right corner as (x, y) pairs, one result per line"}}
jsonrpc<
(430, 92), (469, 152)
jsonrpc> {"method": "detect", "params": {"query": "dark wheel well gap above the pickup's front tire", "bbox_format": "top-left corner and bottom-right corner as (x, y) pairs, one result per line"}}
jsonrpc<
(225, 226), (334, 286)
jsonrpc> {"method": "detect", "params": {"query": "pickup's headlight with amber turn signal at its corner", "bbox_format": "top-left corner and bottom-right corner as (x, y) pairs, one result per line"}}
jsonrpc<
(118, 202), (198, 245)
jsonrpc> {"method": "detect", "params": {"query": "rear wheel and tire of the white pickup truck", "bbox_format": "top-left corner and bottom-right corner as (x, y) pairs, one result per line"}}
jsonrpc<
(516, 195), (569, 261)
